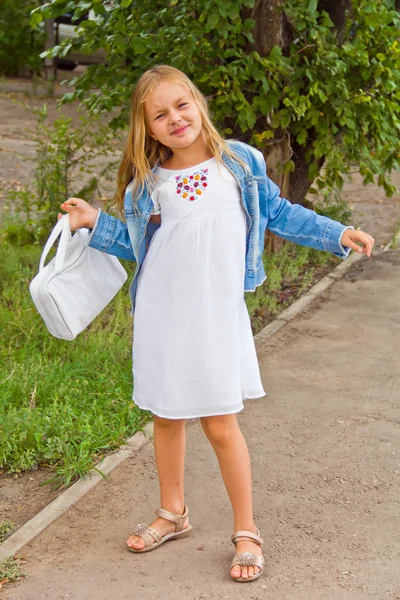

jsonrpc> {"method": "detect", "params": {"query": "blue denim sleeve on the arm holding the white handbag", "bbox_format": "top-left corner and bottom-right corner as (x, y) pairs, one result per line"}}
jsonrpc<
(88, 208), (136, 261)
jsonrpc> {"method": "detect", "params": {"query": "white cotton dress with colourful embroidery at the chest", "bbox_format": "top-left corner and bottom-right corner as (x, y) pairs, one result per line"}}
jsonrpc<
(132, 158), (265, 419)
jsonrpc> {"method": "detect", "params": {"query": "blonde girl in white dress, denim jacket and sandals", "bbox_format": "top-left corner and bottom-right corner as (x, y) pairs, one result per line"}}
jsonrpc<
(59, 66), (374, 582)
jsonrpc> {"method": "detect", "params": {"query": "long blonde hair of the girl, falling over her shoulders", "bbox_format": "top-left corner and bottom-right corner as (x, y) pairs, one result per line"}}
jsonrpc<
(114, 65), (244, 214)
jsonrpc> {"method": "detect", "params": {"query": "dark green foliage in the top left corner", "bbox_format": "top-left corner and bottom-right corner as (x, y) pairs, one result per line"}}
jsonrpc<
(0, 0), (44, 75)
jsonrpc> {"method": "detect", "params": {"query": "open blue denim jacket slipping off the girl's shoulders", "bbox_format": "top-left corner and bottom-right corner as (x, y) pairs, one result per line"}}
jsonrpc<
(89, 140), (354, 315)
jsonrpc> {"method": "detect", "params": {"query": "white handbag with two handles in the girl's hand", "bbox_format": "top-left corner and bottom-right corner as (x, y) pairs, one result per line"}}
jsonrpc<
(29, 213), (127, 340)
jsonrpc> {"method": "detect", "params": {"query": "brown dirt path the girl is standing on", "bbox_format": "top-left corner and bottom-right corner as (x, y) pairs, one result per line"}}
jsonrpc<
(4, 251), (400, 600)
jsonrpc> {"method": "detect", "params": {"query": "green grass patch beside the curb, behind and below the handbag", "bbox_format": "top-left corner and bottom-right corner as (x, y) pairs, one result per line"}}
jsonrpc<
(0, 242), (150, 485)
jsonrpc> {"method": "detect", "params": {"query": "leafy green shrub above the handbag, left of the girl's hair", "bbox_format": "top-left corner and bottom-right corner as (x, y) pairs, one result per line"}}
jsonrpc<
(0, 104), (116, 245)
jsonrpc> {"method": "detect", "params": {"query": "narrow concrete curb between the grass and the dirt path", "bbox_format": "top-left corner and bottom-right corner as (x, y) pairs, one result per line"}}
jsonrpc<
(0, 241), (390, 561)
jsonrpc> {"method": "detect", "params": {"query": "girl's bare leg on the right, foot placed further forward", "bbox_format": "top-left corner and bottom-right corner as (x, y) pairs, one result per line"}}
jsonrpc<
(200, 414), (262, 578)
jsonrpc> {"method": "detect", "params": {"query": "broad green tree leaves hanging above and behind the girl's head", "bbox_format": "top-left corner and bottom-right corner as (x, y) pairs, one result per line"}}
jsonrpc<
(33, 0), (400, 195)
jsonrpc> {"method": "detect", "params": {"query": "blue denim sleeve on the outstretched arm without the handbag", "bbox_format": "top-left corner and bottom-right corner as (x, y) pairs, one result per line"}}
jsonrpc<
(253, 152), (354, 259)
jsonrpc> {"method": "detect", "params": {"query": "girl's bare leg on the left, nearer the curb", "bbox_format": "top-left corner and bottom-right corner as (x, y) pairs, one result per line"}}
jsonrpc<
(127, 416), (189, 550)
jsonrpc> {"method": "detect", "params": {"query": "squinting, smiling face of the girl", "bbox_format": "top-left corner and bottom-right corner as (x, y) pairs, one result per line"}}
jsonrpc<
(144, 81), (203, 152)
